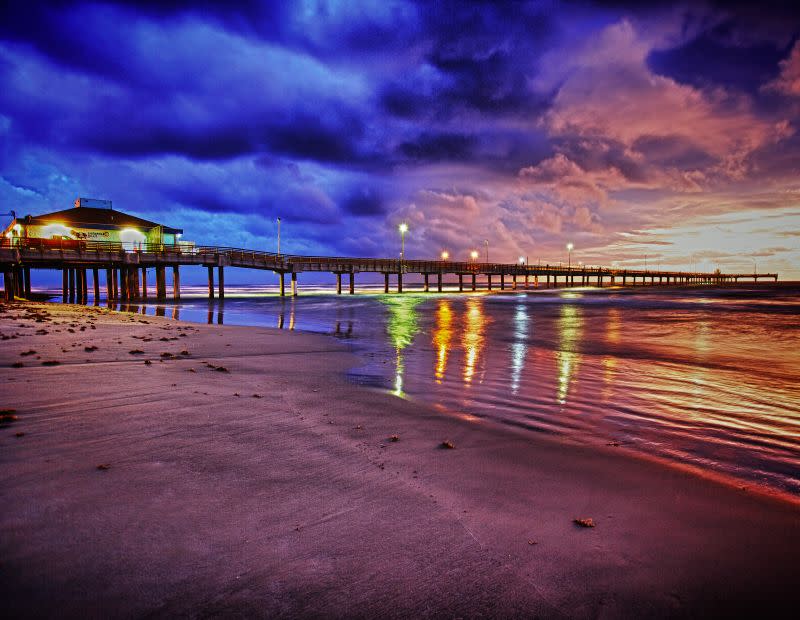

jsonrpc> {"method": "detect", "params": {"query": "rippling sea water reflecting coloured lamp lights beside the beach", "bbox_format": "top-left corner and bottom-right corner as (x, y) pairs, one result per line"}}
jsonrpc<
(61, 285), (800, 497)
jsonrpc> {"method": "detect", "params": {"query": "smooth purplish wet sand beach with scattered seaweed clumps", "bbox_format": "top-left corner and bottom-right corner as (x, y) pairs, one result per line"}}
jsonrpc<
(0, 303), (800, 618)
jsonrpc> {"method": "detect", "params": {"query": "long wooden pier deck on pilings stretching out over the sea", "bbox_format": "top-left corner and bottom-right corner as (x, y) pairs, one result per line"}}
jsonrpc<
(0, 239), (778, 301)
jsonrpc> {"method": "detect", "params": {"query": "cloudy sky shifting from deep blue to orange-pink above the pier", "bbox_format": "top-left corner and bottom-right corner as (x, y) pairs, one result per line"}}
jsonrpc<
(0, 0), (800, 279)
